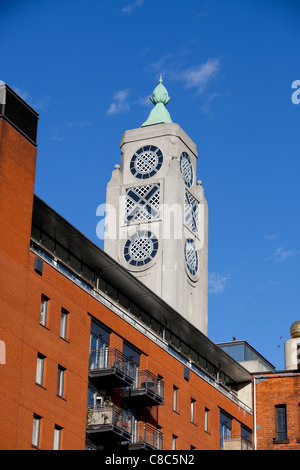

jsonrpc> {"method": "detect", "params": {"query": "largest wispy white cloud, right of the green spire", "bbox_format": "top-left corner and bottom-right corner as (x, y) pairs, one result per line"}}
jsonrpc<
(180, 59), (221, 93)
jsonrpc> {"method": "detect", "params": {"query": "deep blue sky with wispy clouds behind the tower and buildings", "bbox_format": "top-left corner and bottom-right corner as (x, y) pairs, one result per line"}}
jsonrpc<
(0, 0), (300, 369)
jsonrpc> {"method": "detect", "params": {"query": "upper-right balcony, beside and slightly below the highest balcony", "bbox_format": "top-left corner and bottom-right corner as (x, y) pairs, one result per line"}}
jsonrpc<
(122, 369), (164, 406)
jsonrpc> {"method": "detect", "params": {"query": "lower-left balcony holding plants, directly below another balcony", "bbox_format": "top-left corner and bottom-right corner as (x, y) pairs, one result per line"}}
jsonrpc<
(87, 405), (133, 442)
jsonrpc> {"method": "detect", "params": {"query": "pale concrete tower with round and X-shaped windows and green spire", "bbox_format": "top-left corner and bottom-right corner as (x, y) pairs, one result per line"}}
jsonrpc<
(104, 79), (208, 334)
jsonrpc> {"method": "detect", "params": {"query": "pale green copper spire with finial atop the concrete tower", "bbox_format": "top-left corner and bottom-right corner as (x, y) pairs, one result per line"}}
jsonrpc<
(141, 76), (172, 127)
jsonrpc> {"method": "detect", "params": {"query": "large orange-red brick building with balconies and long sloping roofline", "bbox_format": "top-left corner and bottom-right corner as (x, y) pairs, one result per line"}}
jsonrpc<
(0, 85), (255, 450)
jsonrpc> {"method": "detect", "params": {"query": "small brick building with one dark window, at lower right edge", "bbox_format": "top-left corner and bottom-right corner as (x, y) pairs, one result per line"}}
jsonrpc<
(253, 321), (300, 450)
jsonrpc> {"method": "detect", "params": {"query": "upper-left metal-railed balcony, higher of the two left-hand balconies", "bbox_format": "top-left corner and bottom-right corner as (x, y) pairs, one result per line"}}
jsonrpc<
(89, 349), (137, 387)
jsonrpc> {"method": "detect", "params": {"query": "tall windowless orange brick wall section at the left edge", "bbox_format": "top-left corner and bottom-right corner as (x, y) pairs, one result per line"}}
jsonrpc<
(0, 119), (36, 449)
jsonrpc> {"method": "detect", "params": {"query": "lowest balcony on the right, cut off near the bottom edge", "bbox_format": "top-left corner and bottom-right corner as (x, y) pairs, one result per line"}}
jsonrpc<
(129, 423), (163, 450)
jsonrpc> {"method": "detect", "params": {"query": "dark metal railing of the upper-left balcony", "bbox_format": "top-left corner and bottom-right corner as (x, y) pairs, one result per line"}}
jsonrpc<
(90, 348), (137, 384)
